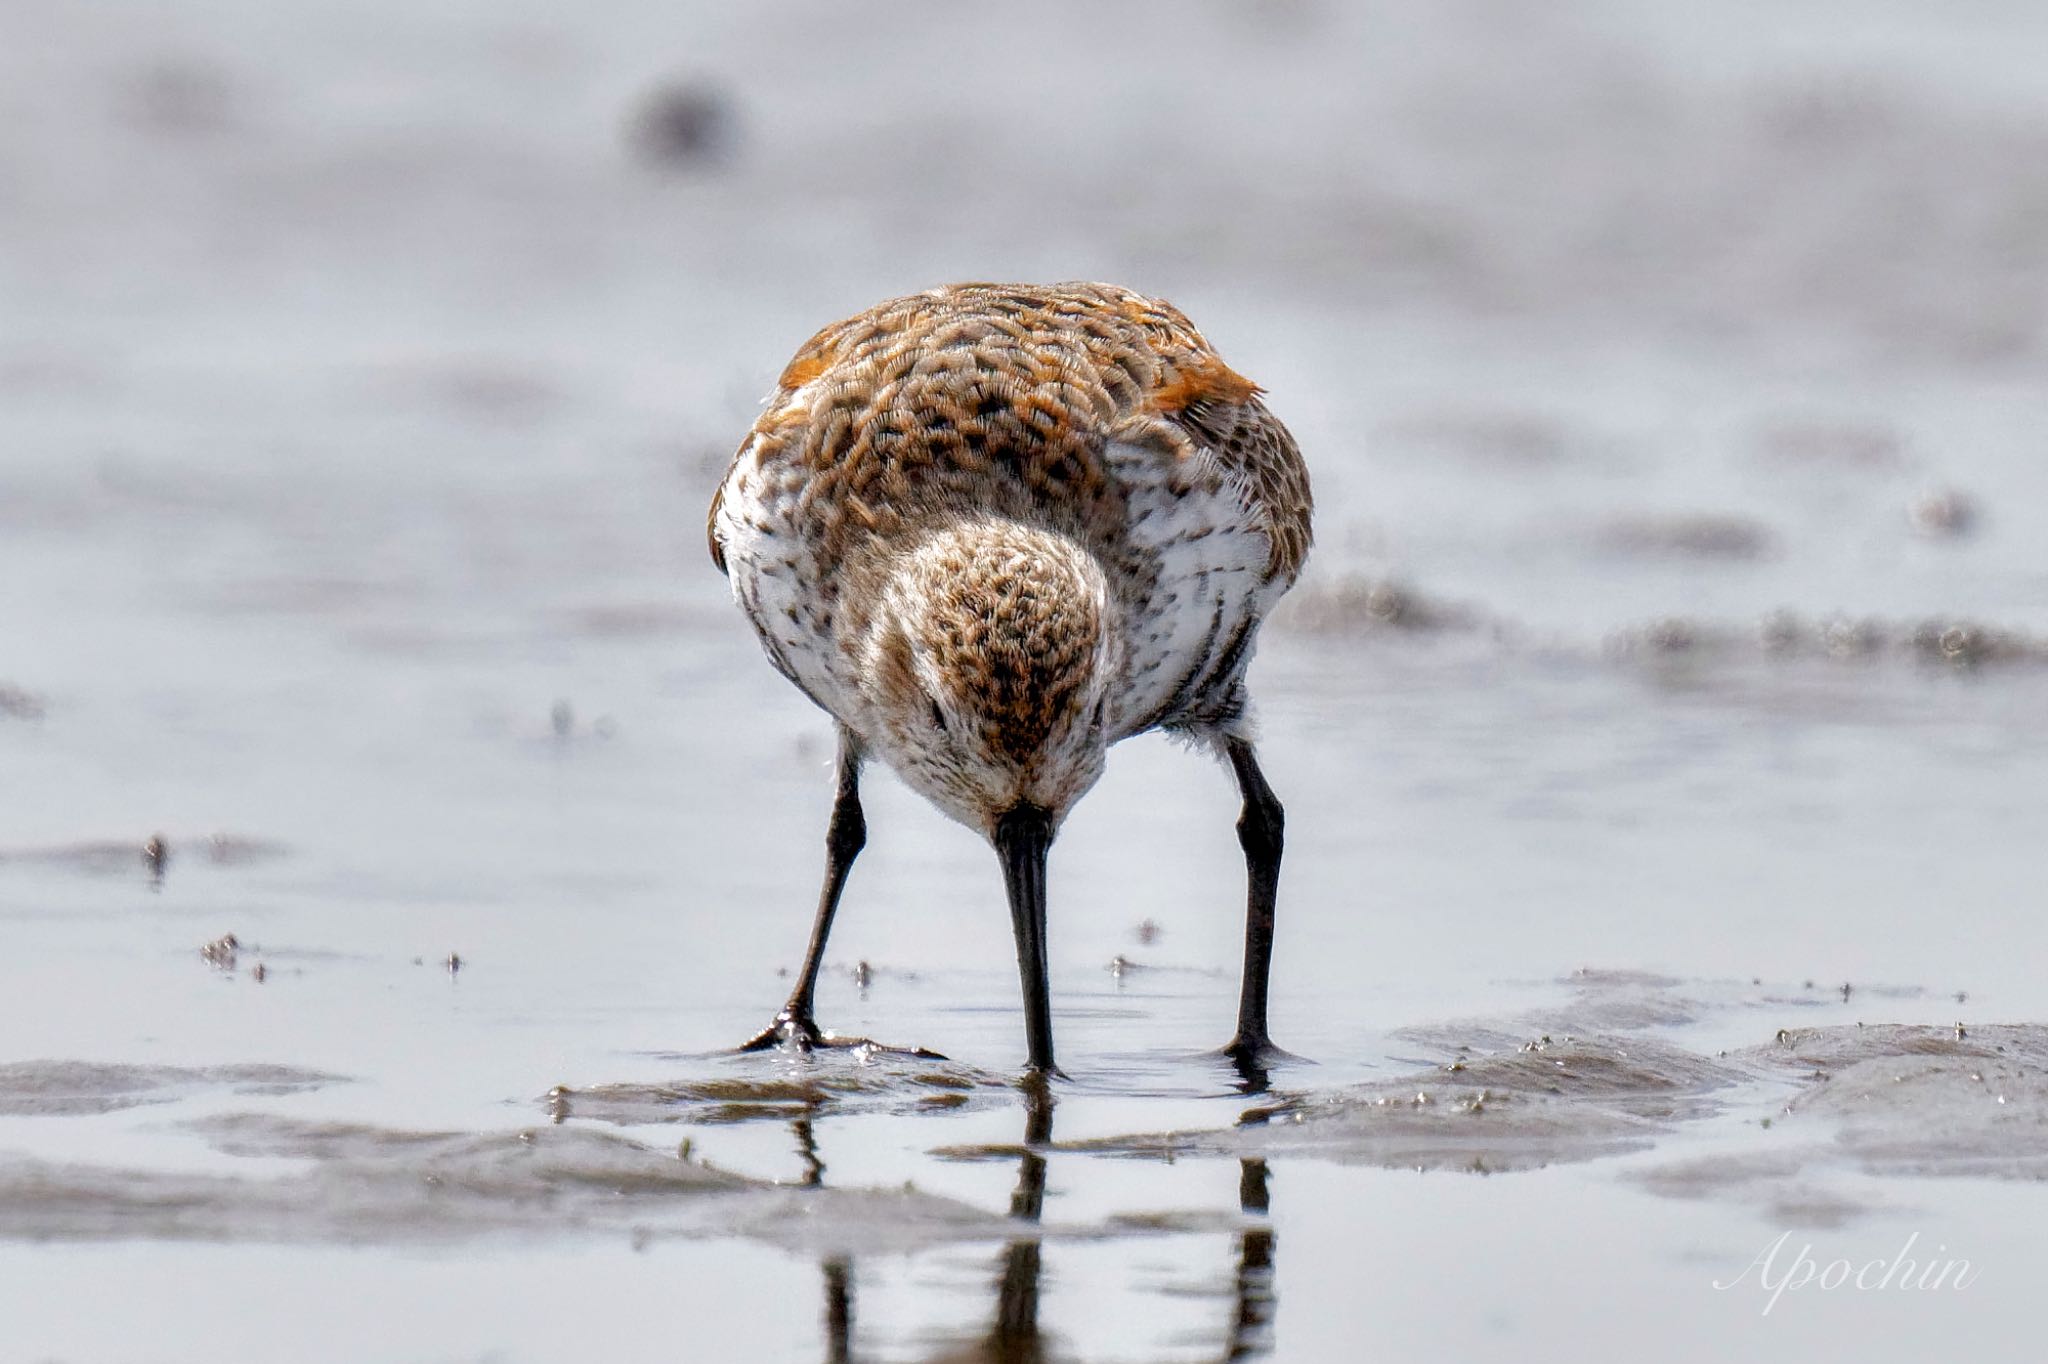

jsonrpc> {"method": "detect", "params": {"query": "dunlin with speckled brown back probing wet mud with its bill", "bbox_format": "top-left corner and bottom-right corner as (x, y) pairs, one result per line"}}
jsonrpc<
(711, 285), (1311, 1073)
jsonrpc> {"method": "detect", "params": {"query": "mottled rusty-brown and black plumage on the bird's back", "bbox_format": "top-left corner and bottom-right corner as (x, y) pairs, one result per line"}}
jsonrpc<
(711, 285), (1311, 582)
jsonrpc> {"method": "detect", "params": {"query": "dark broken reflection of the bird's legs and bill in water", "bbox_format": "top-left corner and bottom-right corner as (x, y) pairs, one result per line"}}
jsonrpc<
(791, 1077), (1274, 1364)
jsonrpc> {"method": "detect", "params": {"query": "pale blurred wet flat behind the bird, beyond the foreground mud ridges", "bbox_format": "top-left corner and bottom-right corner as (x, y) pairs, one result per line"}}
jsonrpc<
(0, 0), (2048, 1339)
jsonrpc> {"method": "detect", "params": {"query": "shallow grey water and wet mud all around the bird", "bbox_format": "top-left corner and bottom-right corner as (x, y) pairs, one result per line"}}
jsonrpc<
(0, 0), (2048, 1360)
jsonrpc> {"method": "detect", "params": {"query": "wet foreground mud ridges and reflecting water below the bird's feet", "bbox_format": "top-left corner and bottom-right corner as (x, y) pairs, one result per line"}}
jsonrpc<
(0, 973), (2048, 1358)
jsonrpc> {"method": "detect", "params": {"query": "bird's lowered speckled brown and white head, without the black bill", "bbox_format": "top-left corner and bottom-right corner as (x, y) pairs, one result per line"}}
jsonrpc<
(858, 520), (1122, 842)
